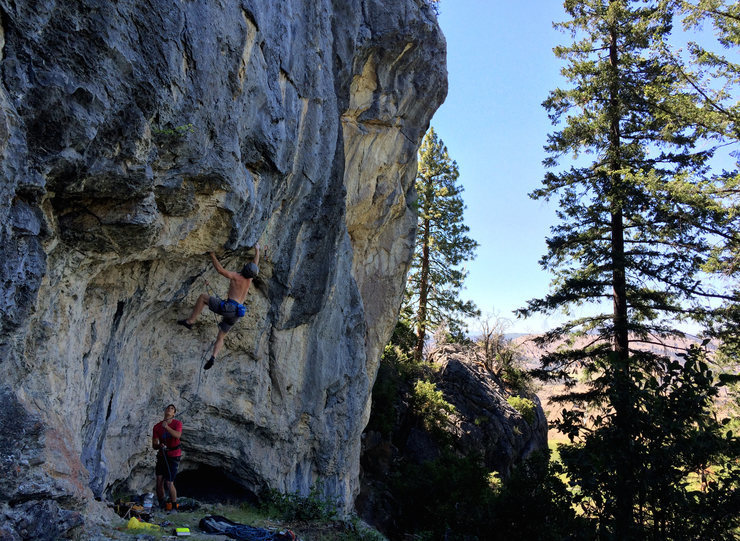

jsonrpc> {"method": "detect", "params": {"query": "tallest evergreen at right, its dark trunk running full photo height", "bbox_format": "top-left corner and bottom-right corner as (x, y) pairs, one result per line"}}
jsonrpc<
(520, 0), (740, 540)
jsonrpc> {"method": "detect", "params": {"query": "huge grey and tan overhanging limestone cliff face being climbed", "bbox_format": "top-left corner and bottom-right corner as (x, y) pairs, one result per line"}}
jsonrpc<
(0, 0), (446, 531)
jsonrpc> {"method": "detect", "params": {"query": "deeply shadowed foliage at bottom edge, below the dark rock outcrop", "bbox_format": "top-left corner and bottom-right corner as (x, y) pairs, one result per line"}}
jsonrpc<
(394, 452), (592, 541)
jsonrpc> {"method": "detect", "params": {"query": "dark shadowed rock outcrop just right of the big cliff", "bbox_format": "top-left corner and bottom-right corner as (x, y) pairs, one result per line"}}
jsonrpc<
(355, 344), (547, 537)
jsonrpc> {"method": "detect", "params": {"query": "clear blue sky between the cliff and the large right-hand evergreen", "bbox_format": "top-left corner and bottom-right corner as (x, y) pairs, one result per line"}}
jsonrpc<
(432, 0), (568, 333)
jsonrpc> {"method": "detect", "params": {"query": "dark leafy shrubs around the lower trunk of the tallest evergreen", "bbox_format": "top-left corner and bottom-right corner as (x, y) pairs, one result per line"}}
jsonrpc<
(556, 348), (740, 540)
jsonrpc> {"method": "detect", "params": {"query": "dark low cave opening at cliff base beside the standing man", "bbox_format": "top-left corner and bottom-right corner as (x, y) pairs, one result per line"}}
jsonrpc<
(175, 464), (258, 504)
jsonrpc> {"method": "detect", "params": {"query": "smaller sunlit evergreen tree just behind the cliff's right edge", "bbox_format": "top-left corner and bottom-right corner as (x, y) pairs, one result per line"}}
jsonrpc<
(402, 128), (479, 360)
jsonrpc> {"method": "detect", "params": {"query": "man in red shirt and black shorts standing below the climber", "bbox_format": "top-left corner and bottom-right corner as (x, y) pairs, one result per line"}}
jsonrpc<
(152, 404), (182, 509)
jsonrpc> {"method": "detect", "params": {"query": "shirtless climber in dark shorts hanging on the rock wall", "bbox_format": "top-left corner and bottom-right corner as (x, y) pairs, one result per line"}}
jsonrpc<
(177, 243), (260, 370)
